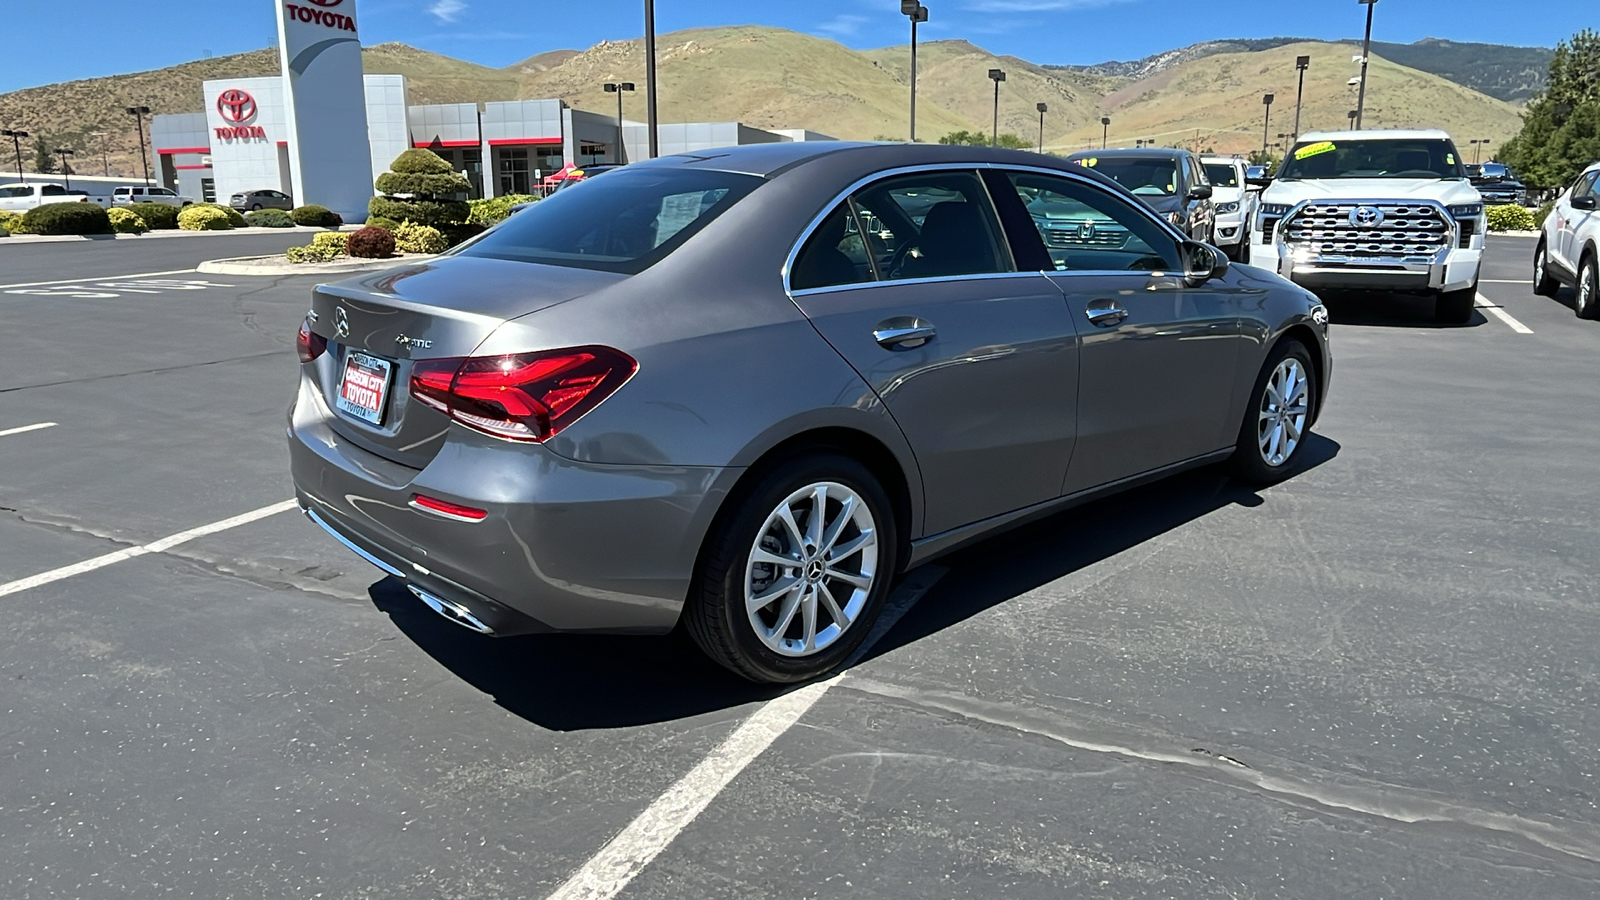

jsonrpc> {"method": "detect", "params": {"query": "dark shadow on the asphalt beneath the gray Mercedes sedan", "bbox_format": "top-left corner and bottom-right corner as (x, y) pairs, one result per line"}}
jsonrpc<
(368, 434), (1339, 732)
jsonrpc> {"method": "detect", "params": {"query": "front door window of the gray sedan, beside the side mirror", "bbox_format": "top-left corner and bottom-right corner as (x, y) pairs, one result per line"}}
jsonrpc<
(1006, 171), (1179, 272)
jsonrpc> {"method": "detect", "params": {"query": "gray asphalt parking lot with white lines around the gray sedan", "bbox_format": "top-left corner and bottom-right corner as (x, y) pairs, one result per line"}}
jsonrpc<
(0, 235), (1600, 900)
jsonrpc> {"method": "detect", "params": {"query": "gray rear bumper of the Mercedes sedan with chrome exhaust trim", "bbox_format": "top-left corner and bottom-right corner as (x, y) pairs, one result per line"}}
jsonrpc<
(288, 378), (739, 634)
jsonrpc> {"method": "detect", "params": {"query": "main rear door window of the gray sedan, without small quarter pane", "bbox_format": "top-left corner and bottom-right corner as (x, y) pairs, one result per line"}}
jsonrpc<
(851, 171), (1013, 280)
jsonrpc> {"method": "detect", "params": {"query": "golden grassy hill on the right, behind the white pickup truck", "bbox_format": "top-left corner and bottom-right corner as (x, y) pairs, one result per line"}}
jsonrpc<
(1053, 43), (1522, 159)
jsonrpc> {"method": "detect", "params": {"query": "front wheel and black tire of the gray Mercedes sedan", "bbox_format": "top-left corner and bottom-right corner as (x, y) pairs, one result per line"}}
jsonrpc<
(1229, 340), (1317, 485)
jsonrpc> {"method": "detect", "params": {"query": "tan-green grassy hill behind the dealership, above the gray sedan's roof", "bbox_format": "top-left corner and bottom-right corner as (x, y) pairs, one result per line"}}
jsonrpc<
(522, 26), (976, 139)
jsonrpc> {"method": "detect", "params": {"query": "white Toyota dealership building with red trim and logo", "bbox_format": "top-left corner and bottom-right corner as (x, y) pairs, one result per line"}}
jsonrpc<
(150, 75), (827, 203)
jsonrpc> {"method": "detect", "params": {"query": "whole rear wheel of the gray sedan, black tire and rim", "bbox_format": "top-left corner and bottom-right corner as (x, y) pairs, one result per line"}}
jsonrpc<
(683, 450), (899, 684)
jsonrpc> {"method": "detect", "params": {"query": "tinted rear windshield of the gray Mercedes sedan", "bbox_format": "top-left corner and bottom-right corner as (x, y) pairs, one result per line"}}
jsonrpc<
(461, 167), (762, 269)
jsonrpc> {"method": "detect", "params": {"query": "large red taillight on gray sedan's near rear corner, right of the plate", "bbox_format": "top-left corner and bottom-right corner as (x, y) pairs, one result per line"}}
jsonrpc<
(411, 348), (638, 442)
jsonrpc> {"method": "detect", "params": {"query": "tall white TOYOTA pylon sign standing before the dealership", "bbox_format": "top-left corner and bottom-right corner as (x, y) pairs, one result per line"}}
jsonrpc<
(278, 0), (373, 221)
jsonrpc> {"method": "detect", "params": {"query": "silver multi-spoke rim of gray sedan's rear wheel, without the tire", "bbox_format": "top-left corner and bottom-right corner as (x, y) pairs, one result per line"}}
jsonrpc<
(744, 482), (878, 657)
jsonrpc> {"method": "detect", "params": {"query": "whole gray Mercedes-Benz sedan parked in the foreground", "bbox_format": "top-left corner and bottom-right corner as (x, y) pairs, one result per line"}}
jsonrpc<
(290, 143), (1331, 682)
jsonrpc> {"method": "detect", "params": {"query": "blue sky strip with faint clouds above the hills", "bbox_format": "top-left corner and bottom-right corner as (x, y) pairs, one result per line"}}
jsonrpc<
(0, 0), (1600, 93)
